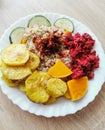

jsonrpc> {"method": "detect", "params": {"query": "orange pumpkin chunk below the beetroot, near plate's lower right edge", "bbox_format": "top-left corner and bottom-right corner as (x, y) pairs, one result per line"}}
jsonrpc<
(67, 76), (88, 101)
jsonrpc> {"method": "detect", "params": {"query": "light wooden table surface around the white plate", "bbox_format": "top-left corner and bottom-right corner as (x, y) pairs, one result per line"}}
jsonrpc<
(0, 0), (105, 130)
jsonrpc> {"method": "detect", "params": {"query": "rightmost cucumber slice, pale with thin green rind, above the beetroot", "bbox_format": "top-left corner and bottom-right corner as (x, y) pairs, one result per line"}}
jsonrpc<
(54, 18), (74, 32)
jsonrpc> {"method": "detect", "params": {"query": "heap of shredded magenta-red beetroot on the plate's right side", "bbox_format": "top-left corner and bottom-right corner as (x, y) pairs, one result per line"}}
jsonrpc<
(64, 33), (99, 79)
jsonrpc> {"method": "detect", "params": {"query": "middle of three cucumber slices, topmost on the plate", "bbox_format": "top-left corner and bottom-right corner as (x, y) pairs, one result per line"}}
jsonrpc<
(28, 15), (51, 27)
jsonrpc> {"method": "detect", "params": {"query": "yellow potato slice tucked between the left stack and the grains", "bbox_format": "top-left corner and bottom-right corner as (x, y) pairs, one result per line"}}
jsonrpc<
(27, 52), (40, 71)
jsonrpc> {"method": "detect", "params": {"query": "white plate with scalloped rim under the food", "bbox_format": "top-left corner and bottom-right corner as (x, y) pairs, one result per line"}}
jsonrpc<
(0, 13), (105, 117)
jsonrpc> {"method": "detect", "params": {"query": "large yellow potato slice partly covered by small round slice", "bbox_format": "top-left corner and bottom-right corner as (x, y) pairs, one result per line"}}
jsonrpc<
(25, 71), (50, 103)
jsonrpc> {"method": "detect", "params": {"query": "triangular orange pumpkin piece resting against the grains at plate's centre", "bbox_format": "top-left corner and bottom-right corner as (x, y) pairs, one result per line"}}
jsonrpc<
(47, 60), (72, 78)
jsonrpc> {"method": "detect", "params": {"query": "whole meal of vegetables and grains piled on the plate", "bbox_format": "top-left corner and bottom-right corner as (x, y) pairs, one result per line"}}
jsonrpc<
(0, 15), (99, 105)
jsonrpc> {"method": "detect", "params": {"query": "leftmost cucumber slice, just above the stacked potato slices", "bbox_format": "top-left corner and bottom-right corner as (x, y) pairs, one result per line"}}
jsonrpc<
(9, 27), (25, 44)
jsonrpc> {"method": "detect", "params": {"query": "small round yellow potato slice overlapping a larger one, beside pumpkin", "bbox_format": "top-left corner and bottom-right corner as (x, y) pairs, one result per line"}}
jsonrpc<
(46, 78), (67, 98)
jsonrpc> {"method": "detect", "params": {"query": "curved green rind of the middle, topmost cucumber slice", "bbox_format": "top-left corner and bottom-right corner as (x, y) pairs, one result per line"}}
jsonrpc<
(27, 15), (51, 27)
